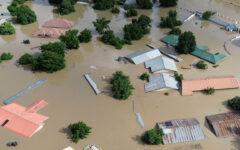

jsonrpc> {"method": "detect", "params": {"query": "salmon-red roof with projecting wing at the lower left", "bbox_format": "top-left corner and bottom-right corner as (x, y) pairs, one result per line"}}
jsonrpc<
(0, 100), (48, 138)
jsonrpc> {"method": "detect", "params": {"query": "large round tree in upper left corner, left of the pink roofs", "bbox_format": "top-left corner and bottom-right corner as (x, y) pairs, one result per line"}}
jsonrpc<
(17, 4), (37, 25)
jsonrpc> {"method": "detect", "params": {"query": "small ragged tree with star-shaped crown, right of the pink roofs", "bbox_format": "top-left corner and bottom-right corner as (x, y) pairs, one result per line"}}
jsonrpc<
(93, 18), (111, 34)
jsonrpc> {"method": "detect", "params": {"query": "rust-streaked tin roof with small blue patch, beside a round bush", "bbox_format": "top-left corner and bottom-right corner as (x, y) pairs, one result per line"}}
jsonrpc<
(157, 118), (205, 144)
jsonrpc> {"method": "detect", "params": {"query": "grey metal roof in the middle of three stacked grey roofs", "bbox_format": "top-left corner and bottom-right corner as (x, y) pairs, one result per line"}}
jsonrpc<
(145, 56), (177, 73)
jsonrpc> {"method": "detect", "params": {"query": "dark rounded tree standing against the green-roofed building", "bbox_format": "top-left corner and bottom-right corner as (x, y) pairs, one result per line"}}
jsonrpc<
(176, 31), (196, 54)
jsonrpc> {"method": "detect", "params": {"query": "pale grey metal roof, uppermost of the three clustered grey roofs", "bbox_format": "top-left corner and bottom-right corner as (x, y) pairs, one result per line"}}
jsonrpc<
(125, 49), (162, 65)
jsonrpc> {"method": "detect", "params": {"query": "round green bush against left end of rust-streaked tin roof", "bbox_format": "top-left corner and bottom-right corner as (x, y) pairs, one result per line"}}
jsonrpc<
(141, 129), (164, 145)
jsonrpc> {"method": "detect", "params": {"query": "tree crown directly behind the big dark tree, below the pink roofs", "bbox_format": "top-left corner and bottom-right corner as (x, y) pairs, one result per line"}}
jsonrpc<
(40, 42), (65, 57)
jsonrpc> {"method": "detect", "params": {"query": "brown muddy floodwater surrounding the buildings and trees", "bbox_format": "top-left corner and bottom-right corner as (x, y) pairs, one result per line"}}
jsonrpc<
(0, 0), (240, 150)
